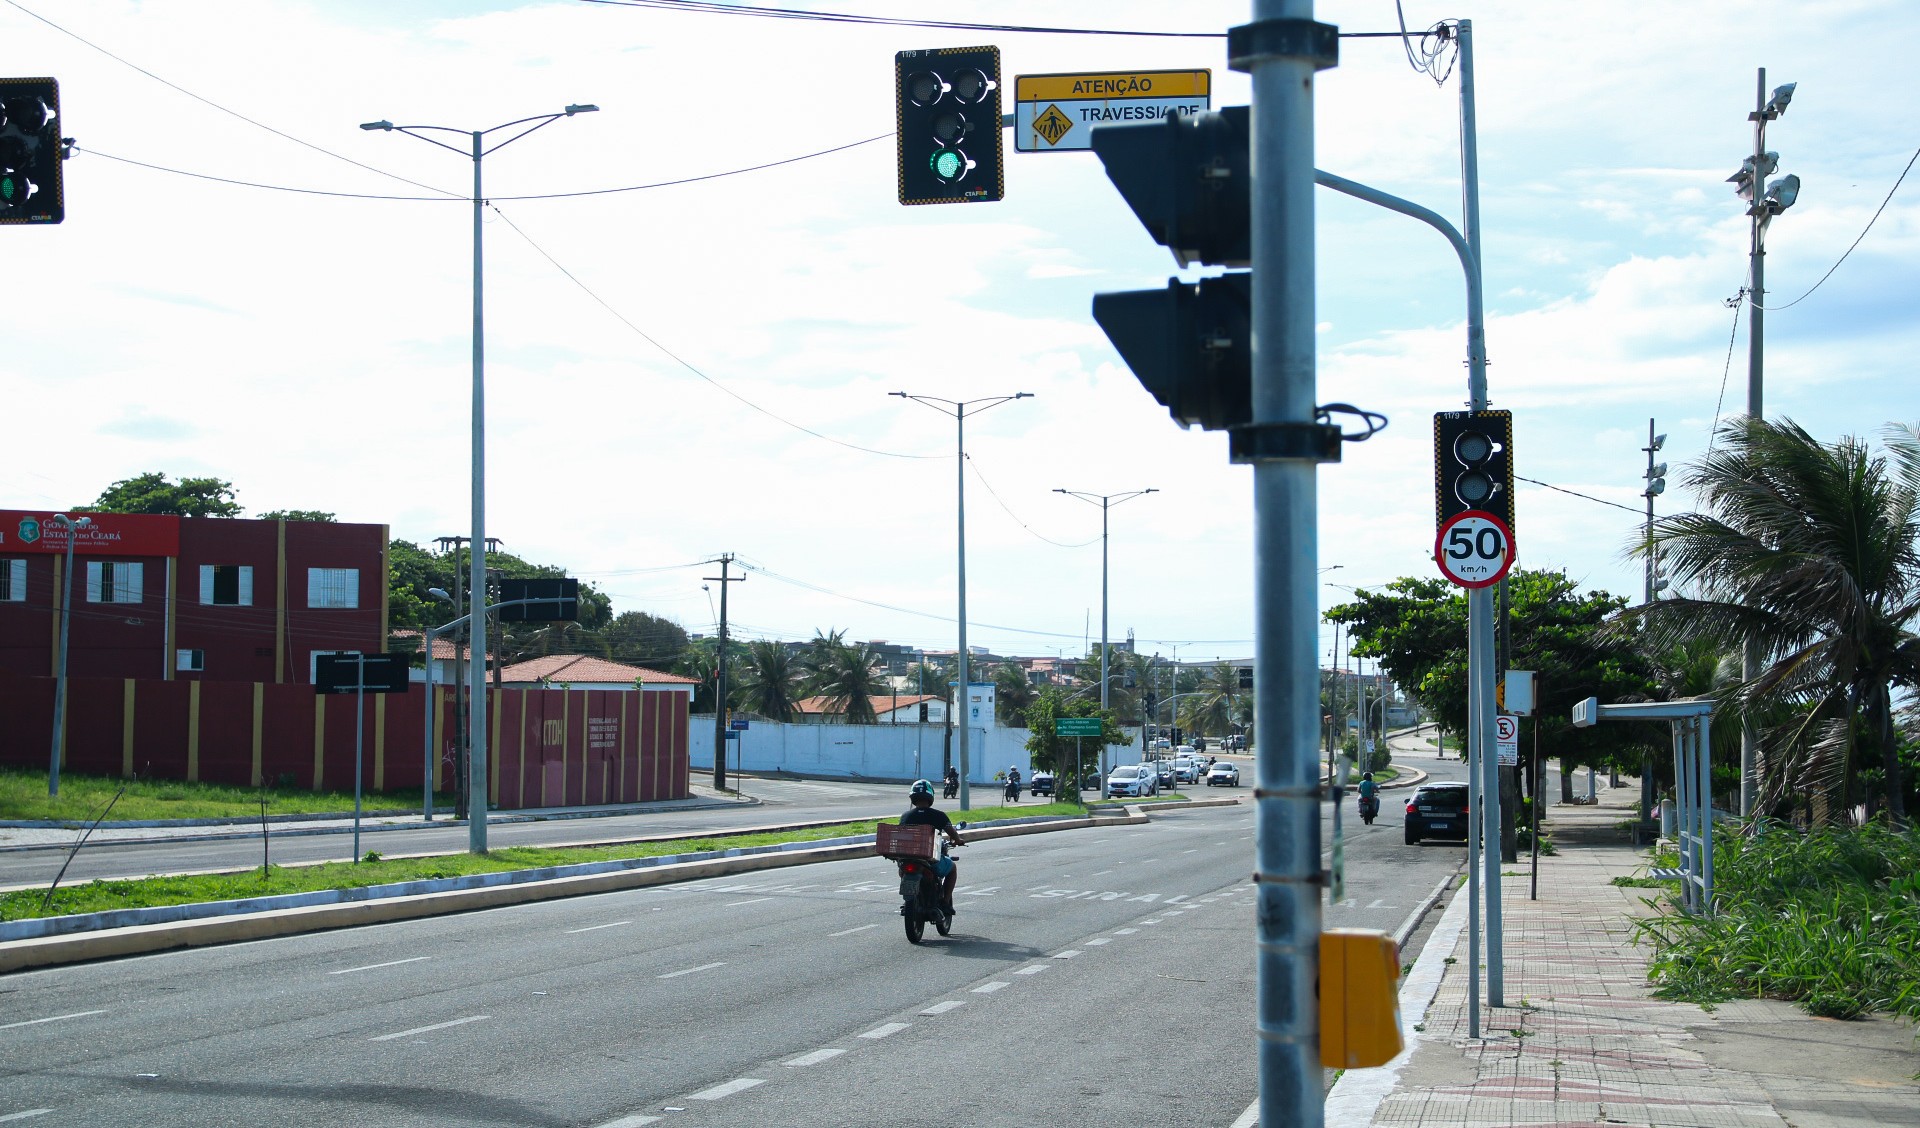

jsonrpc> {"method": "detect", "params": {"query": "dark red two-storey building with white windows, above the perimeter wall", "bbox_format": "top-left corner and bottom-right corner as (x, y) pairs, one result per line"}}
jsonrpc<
(0, 510), (388, 685)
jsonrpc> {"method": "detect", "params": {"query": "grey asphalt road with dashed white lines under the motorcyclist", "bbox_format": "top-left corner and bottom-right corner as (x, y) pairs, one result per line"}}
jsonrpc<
(0, 764), (1463, 1128)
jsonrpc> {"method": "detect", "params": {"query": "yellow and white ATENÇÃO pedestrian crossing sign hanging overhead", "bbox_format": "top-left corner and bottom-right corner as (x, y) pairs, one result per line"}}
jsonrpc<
(1014, 71), (1213, 153)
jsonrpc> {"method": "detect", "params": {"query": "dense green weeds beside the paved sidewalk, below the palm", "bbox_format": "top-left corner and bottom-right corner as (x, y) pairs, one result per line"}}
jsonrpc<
(1638, 825), (1920, 1022)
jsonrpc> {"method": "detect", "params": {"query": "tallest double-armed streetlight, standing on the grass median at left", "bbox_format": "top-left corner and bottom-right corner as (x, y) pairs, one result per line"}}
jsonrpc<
(361, 106), (599, 854)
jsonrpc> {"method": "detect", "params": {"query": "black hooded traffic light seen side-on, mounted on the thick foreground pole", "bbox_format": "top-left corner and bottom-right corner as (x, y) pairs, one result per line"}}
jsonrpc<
(1092, 106), (1254, 430)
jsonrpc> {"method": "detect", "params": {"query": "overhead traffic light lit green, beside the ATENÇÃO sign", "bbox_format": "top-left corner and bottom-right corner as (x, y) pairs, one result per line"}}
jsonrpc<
(893, 46), (1004, 203)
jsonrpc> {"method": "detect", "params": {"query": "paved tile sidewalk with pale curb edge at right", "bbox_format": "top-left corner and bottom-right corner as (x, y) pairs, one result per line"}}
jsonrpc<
(1327, 781), (1920, 1128)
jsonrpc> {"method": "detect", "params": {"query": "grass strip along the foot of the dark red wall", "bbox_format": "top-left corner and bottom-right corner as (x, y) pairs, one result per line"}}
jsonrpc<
(0, 767), (453, 825)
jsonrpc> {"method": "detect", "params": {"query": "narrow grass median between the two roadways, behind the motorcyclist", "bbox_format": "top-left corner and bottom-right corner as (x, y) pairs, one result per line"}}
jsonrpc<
(0, 804), (1087, 921)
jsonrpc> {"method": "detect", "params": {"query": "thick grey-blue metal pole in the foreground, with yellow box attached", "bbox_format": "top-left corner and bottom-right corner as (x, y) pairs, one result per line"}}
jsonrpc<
(1246, 0), (1325, 1128)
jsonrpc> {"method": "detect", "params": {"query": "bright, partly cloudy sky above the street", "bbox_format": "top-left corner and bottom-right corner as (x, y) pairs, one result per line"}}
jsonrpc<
(0, 0), (1920, 662)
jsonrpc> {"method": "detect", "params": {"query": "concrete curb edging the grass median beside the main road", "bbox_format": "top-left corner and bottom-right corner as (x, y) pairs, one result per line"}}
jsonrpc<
(0, 811), (1148, 973)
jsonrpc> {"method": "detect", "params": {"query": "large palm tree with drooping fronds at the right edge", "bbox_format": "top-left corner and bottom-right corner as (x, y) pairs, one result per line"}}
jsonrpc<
(1634, 416), (1920, 823)
